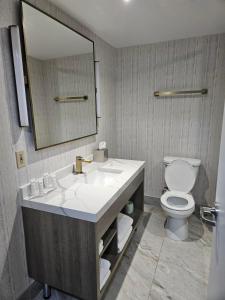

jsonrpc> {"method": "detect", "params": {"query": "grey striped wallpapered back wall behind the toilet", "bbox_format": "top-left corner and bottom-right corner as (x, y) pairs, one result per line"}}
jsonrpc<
(116, 34), (225, 204)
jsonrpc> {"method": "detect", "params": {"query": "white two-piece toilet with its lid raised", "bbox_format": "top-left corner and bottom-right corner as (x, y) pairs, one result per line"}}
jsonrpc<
(160, 156), (201, 241)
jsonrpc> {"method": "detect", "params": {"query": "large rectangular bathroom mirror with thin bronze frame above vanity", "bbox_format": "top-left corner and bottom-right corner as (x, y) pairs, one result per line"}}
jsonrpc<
(22, 1), (97, 150)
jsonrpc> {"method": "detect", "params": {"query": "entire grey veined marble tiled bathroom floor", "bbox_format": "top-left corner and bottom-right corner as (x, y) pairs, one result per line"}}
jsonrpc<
(35, 205), (212, 300)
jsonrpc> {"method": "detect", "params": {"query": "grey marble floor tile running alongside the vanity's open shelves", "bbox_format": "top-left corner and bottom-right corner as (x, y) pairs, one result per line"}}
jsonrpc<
(105, 212), (163, 300)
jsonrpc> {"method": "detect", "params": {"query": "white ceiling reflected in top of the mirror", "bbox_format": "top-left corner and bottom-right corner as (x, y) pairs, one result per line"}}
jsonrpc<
(23, 3), (93, 60)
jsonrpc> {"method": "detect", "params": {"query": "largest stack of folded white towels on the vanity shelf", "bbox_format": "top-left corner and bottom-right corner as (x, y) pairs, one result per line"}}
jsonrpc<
(117, 213), (133, 253)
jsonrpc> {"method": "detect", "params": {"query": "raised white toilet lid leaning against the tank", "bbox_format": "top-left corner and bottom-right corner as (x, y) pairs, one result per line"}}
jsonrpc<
(165, 160), (196, 193)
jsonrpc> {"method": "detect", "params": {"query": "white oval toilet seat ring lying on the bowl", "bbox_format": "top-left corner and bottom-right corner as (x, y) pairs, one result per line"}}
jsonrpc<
(161, 191), (195, 211)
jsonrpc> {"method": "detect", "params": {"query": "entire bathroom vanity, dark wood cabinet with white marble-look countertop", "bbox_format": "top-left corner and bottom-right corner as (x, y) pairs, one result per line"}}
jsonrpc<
(21, 159), (145, 300)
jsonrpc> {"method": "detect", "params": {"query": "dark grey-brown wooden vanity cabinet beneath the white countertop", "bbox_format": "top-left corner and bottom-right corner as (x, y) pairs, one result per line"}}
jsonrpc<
(22, 170), (144, 300)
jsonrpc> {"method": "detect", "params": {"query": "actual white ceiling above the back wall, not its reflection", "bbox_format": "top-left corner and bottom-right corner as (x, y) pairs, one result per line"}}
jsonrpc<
(50, 0), (225, 48)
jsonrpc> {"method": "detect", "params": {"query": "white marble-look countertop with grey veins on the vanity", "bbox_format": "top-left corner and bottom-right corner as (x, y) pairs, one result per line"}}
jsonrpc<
(22, 159), (145, 222)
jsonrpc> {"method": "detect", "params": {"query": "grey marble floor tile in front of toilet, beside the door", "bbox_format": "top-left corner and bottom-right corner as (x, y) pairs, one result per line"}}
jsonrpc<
(149, 216), (212, 300)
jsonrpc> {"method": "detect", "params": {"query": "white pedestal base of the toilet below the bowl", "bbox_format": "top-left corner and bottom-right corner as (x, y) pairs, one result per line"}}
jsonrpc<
(165, 217), (188, 241)
